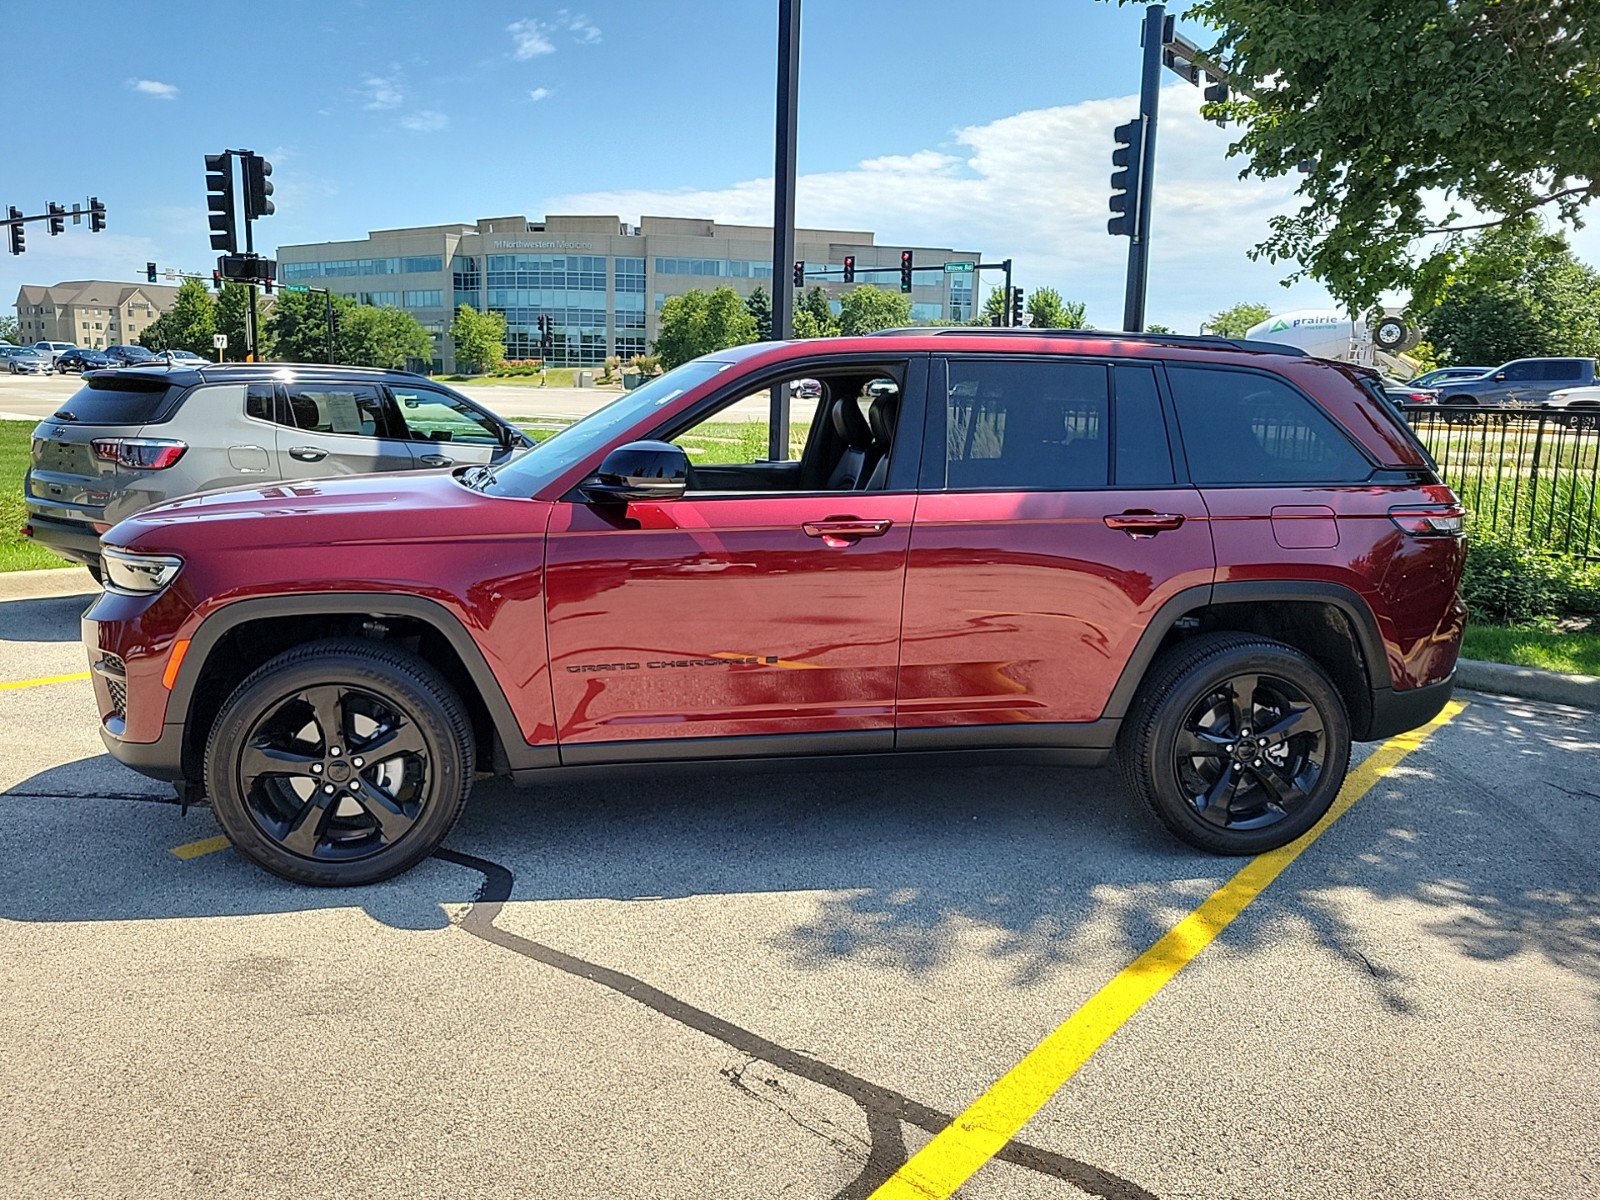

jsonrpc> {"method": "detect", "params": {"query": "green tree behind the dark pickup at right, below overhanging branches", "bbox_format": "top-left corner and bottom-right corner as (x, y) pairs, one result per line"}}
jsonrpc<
(1422, 219), (1600, 366)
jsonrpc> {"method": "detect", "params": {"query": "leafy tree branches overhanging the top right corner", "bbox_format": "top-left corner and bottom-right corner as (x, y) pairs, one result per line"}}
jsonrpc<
(1186, 0), (1600, 312)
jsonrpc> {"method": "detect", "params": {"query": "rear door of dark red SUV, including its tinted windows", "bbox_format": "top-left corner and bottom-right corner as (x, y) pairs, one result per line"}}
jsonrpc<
(896, 355), (1214, 747)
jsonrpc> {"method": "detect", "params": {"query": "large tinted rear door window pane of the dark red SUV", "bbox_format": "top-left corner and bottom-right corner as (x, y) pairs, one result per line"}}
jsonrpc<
(944, 358), (1110, 491)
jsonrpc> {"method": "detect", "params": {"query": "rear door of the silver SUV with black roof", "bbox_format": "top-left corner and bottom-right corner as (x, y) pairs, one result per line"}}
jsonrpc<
(277, 379), (416, 478)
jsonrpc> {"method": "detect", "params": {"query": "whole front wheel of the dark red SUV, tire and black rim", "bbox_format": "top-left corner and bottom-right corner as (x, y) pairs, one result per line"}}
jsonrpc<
(205, 640), (472, 888)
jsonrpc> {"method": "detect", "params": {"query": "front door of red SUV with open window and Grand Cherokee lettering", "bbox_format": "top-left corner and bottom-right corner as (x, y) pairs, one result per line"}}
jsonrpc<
(546, 358), (925, 762)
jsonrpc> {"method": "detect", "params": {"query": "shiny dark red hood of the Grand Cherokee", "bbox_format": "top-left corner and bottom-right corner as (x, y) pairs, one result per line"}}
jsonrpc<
(104, 472), (544, 552)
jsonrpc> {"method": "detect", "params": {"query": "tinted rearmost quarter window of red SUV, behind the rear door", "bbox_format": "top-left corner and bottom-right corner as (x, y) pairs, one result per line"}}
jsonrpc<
(1166, 365), (1373, 485)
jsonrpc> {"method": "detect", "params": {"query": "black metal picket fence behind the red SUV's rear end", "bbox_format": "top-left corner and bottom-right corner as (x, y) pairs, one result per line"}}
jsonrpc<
(1403, 405), (1600, 560)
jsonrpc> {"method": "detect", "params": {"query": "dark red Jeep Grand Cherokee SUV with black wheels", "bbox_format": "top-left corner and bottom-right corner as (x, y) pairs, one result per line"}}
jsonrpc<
(83, 330), (1466, 885)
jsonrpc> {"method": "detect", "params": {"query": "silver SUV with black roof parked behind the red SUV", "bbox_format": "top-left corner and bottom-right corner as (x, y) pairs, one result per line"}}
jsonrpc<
(22, 363), (533, 579)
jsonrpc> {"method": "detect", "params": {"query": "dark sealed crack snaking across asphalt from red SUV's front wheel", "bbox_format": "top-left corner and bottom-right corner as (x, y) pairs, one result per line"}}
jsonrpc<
(434, 850), (1157, 1200)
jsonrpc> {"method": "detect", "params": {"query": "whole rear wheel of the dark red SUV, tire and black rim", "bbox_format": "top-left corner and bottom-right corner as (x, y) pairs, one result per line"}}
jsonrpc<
(1117, 634), (1350, 854)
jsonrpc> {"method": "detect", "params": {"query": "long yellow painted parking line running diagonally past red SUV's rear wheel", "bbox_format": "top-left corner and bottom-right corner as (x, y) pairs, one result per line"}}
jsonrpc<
(870, 702), (1467, 1200)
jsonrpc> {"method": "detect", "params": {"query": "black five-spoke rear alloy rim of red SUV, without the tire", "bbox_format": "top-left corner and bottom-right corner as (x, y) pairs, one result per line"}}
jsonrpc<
(1173, 674), (1326, 829)
